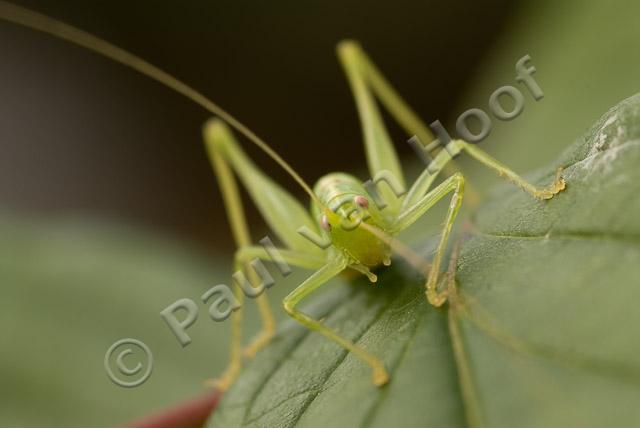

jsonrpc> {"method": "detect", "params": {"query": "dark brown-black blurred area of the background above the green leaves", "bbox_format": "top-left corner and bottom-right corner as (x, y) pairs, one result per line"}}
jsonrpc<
(0, 0), (516, 249)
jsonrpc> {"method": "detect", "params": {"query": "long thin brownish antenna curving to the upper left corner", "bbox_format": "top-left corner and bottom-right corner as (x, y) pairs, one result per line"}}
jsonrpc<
(0, 0), (324, 207)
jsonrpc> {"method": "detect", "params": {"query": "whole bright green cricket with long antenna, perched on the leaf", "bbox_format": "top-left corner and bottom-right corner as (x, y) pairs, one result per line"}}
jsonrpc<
(0, 0), (565, 389)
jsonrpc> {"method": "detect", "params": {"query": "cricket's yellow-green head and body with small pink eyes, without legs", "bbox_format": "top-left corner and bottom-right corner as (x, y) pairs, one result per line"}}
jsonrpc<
(314, 173), (390, 267)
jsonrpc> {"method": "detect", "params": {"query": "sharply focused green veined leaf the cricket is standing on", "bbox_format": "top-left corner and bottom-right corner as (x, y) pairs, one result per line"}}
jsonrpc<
(210, 96), (640, 428)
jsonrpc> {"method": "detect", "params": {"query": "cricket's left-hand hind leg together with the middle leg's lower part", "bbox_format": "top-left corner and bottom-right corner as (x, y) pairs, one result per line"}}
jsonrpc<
(203, 119), (324, 390)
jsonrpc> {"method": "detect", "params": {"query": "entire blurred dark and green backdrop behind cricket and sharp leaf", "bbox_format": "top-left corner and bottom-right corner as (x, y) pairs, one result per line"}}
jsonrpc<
(0, 0), (640, 426)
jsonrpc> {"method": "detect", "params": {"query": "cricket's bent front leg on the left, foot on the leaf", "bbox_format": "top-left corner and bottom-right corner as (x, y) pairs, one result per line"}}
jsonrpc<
(282, 258), (389, 386)
